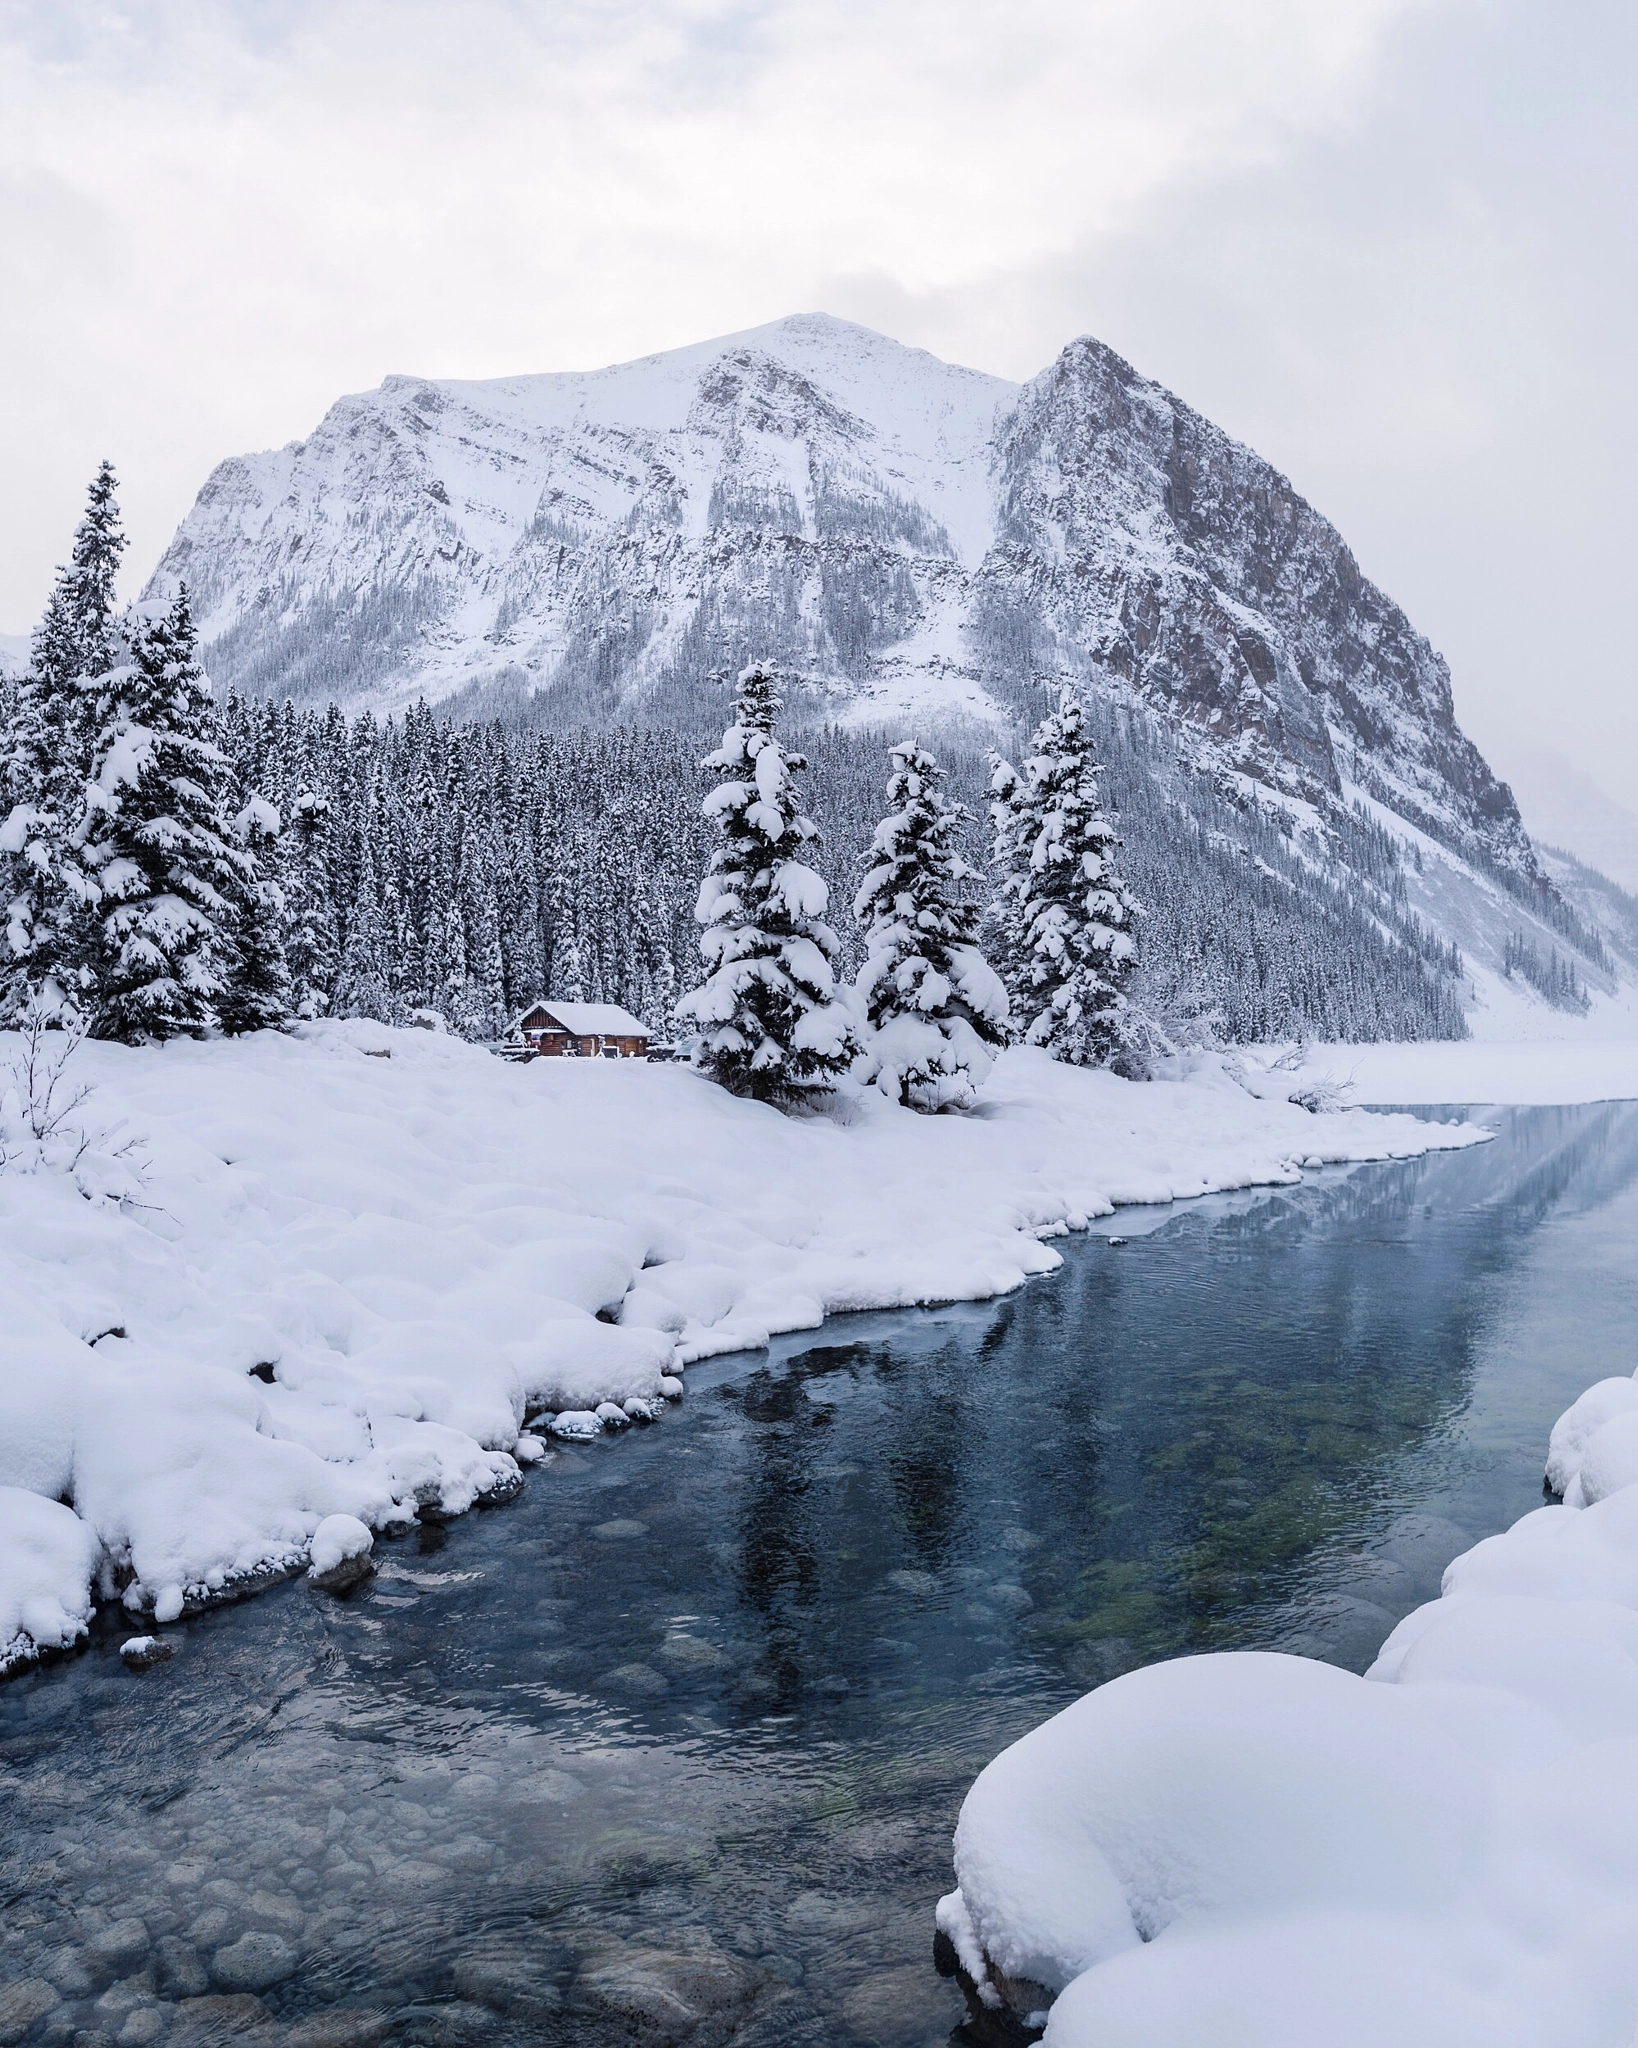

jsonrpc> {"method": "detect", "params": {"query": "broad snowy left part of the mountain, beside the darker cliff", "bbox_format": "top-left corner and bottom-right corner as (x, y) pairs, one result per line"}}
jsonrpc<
(156, 315), (1016, 733)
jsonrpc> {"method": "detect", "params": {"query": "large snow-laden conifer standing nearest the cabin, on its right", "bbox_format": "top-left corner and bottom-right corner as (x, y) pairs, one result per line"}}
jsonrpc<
(676, 664), (860, 1102)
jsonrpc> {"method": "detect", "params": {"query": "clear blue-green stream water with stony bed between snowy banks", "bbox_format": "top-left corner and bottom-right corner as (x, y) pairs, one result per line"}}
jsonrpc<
(0, 1106), (1638, 2048)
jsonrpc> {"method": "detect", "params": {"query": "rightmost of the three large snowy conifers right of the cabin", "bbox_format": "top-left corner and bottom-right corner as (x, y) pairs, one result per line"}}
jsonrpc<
(989, 690), (1136, 1067)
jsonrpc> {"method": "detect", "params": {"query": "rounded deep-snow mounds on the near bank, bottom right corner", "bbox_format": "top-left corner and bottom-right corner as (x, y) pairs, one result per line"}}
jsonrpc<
(938, 1378), (1638, 2048)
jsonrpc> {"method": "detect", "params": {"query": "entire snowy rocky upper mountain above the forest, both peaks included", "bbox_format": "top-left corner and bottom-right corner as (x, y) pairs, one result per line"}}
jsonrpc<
(156, 315), (1536, 883)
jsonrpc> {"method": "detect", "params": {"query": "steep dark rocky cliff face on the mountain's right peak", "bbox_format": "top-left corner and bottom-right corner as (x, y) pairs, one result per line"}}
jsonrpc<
(979, 340), (1532, 870)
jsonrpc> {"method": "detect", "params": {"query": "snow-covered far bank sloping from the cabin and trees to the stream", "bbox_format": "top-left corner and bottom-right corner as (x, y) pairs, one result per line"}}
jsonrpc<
(0, 1024), (1480, 1665)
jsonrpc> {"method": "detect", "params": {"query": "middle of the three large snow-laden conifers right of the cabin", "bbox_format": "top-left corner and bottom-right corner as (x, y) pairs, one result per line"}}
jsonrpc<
(854, 739), (1009, 1110)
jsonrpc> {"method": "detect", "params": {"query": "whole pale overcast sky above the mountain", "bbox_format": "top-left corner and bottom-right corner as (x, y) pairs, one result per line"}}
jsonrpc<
(0, 0), (1638, 807)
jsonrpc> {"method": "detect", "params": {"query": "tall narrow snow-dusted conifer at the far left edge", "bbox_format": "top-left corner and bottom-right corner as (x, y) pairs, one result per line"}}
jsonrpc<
(0, 461), (125, 1022)
